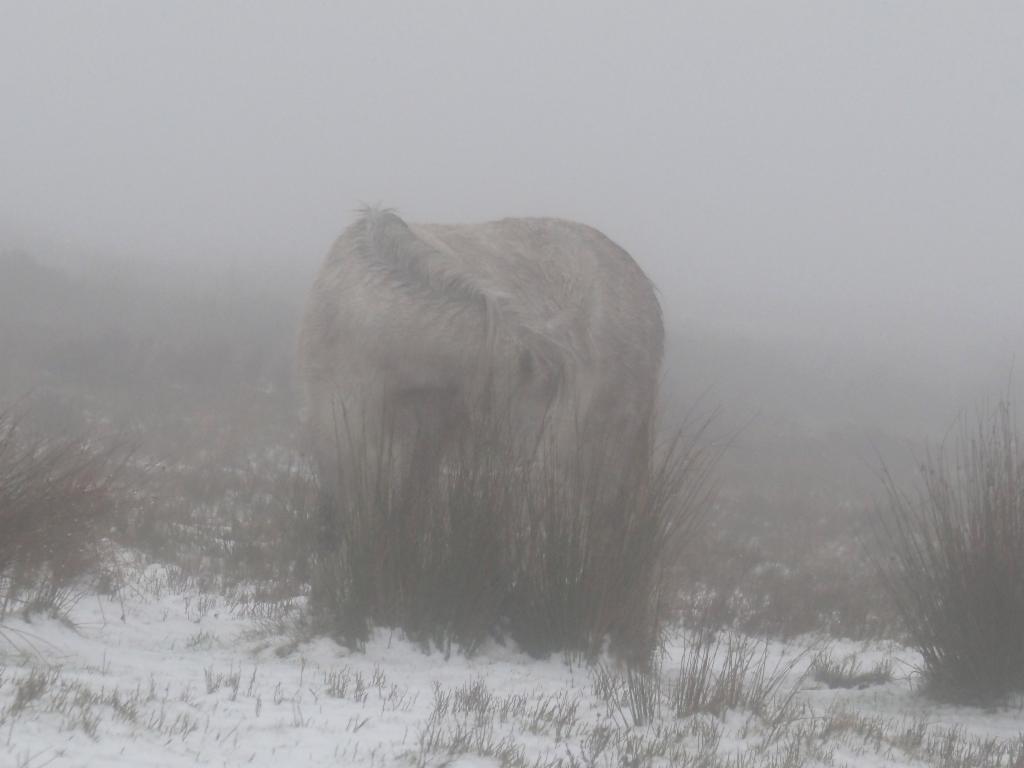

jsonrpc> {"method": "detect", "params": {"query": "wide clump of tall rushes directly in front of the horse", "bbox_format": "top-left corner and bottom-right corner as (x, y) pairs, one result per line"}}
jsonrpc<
(311, 405), (714, 663)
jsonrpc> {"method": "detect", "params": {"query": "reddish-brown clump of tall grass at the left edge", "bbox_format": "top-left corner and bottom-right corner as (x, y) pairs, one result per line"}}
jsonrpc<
(0, 411), (118, 620)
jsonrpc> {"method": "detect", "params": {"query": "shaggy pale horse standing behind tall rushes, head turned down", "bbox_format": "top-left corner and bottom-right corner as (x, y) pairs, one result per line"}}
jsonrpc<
(300, 209), (664, 507)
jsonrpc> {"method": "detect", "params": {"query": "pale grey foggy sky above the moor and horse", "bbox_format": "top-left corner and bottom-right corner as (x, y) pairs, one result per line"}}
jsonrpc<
(0, 0), (1024, 355)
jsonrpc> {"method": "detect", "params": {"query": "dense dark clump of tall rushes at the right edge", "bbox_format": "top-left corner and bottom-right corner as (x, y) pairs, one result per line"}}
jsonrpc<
(879, 401), (1024, 702)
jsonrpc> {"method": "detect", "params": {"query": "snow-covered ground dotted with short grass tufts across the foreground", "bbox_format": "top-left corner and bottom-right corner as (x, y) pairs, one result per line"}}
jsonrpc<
(0, 565), (1024, 768)
